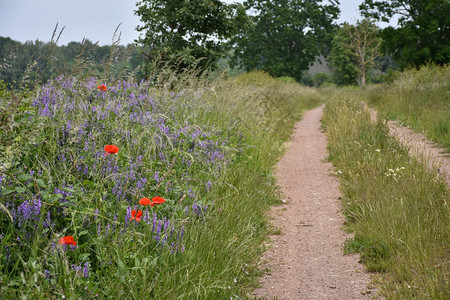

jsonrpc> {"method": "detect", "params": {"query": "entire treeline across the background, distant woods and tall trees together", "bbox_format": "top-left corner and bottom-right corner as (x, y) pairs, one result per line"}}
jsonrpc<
(0, 0), (450, 86)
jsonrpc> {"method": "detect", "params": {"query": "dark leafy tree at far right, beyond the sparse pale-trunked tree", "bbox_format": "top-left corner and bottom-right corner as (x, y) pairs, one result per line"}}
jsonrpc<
(360, 0), (450, 67)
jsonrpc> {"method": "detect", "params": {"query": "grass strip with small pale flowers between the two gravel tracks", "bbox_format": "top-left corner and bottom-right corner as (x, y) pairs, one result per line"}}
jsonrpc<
(323, 92), (450, 299)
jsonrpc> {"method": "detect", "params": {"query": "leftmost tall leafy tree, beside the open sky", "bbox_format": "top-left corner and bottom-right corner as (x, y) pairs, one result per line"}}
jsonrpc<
(135, 0), (247, 72)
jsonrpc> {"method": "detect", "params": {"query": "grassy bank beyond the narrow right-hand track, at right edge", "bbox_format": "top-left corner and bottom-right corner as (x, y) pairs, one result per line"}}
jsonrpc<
(362, 66), (450, 152)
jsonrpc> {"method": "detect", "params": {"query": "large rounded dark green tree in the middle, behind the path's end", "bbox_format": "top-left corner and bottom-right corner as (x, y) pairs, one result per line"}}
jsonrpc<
(235, 0), (339, 81)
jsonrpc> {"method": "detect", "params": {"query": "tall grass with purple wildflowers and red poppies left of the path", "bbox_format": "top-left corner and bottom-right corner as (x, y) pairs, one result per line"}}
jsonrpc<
(0, 67), (321, 299)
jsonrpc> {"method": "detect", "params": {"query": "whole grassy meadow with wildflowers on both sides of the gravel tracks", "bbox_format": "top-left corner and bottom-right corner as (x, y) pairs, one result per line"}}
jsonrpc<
(0, 41), (450, 299)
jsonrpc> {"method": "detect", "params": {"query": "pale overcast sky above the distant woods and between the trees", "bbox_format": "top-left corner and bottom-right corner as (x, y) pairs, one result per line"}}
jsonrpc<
(0, 0), (394, 45)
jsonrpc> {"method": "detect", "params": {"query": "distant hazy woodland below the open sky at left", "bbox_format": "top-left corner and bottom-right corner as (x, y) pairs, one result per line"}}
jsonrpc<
(0, 37), (143, 87)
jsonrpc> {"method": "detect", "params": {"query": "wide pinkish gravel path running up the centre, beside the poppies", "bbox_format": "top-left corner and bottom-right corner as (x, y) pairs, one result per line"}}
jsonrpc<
(254, 107), (370, 300)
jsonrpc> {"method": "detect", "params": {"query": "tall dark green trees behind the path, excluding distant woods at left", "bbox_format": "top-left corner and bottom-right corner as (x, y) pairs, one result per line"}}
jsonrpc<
(136, 0), (450, 86)
